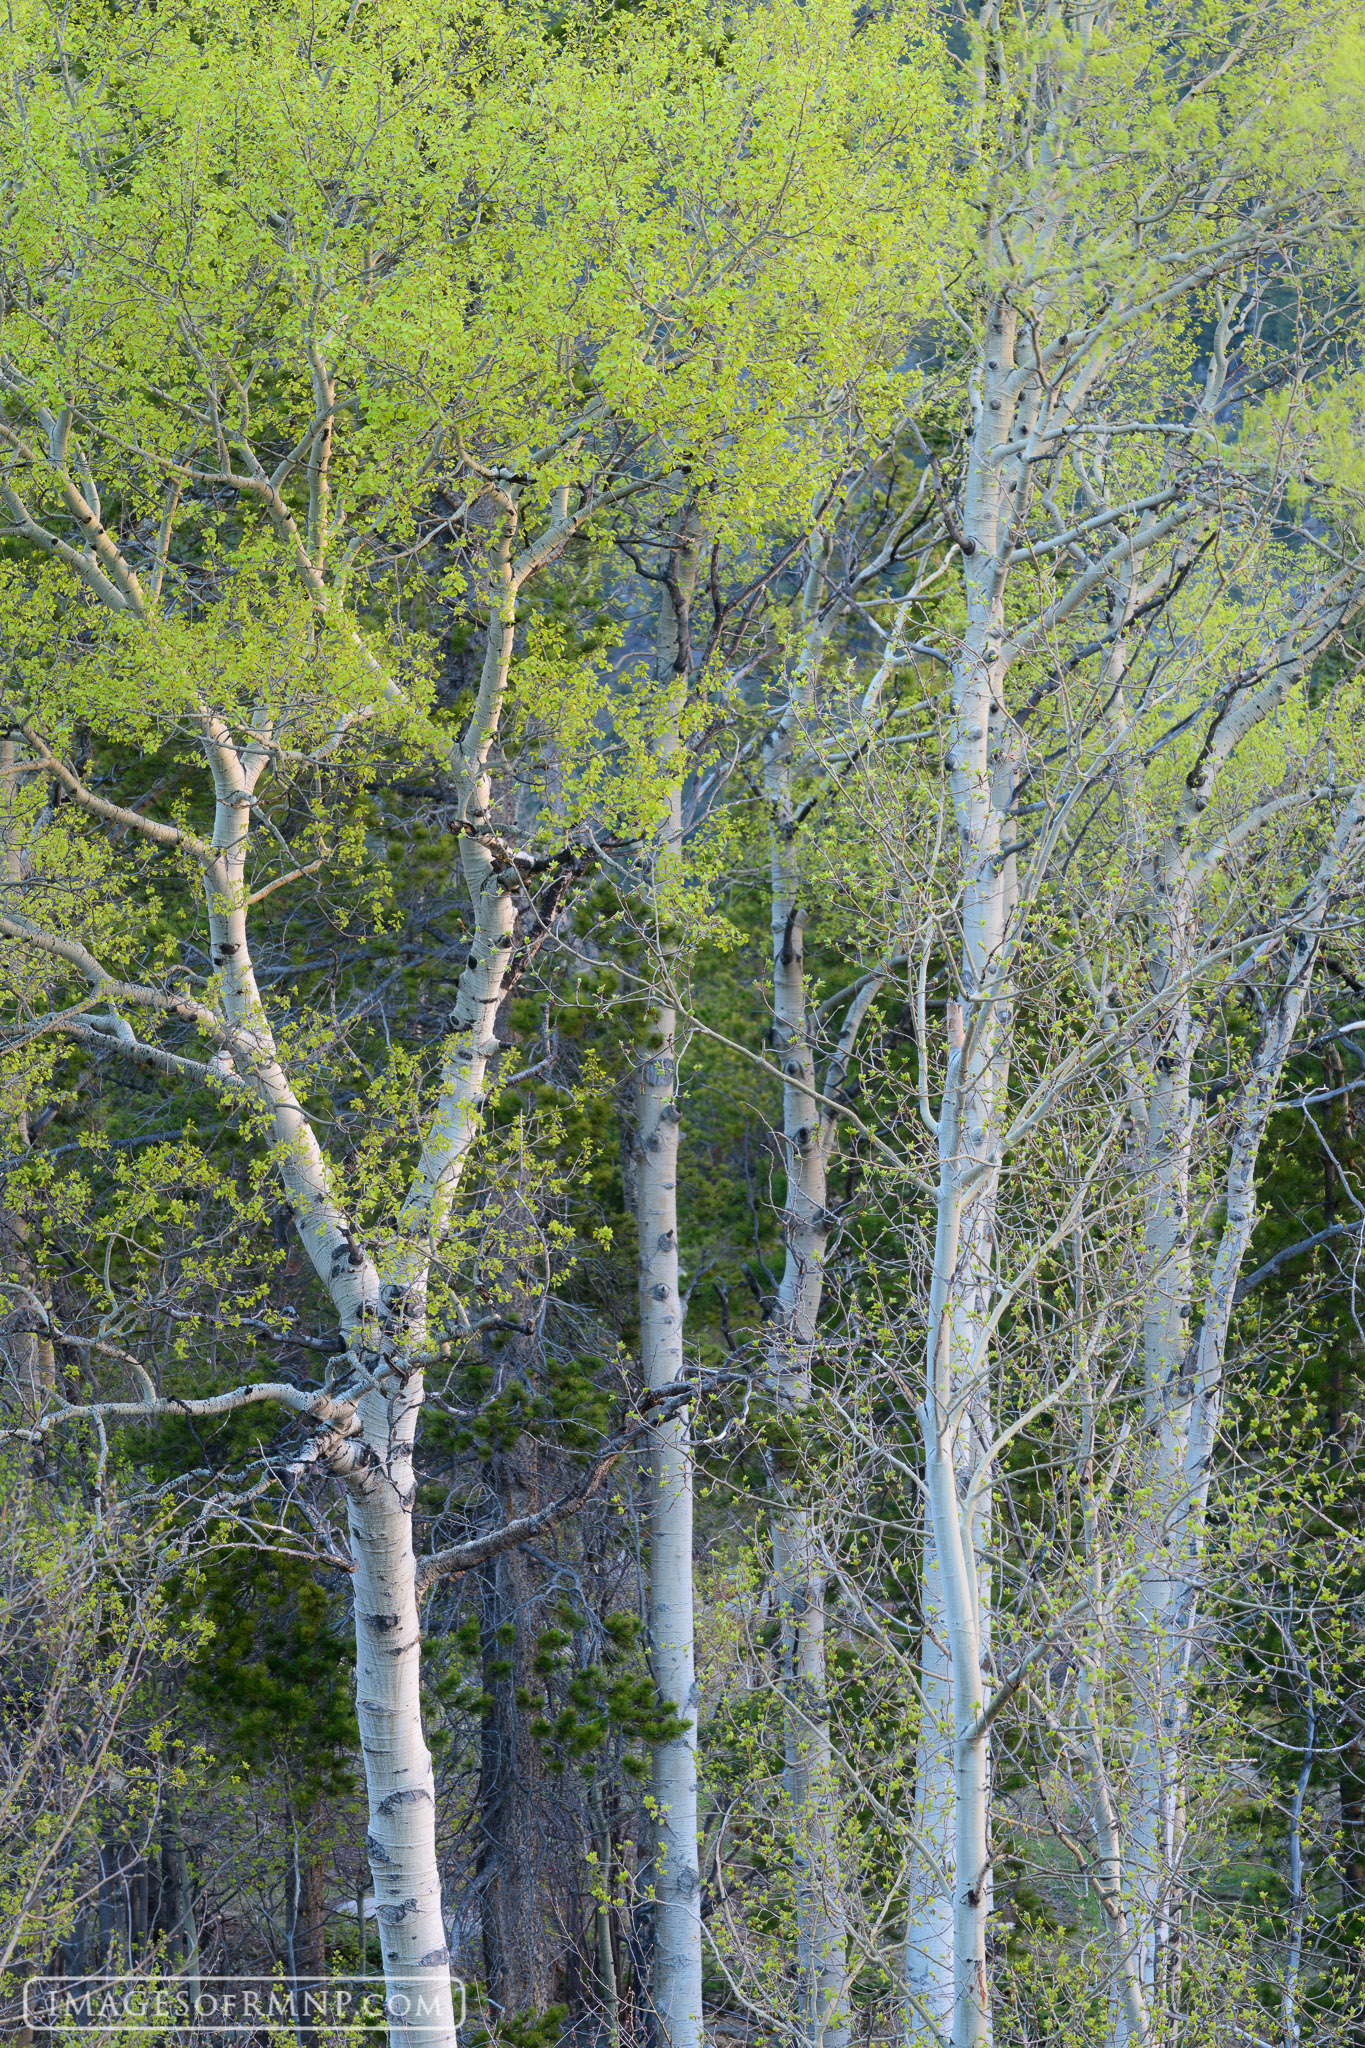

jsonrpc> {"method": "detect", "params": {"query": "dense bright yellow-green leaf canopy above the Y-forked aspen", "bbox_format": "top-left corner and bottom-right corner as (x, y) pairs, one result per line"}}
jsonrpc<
(2, 4), (941, 606)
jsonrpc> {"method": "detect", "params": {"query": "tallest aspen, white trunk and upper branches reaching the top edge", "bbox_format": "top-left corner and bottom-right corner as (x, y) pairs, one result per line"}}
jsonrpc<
(888, 8), (1365, 2048)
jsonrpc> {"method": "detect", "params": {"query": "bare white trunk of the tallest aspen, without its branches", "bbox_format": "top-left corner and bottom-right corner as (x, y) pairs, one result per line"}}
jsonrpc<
(905, 299), (1021, 2048)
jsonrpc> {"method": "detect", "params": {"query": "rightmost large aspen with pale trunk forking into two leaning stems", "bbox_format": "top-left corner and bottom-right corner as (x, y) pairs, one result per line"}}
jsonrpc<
(1064, 403), (1365, 2042)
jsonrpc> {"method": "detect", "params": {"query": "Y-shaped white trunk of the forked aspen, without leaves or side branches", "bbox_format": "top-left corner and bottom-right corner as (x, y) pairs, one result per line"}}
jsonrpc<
(188, 522), (548, 2048)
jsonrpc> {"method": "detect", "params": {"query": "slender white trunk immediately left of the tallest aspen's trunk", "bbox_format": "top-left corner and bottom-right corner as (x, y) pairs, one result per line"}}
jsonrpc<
(763, 559), (849, 2048)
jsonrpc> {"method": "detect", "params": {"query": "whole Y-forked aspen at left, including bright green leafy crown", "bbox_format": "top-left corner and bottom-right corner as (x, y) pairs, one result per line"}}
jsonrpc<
(0, 4), (945, 2048)
